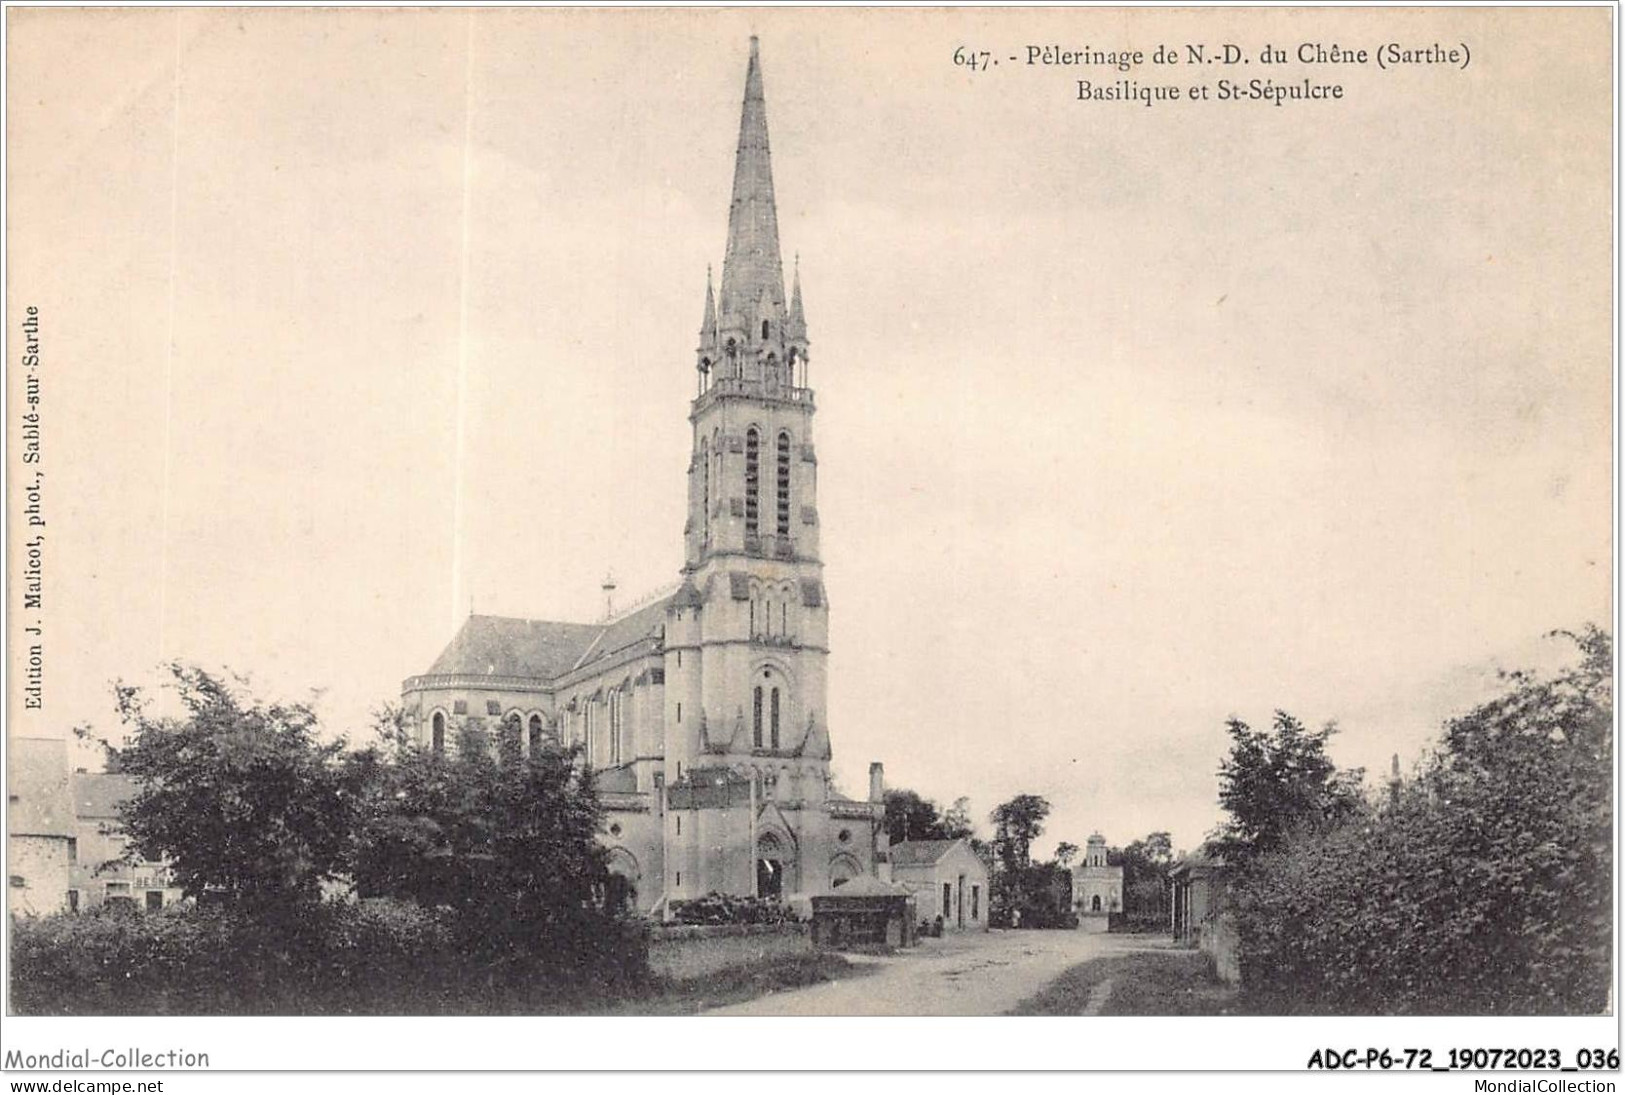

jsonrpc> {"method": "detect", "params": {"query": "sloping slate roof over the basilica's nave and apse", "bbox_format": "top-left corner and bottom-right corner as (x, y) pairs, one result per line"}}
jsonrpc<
(427, 596), (671, 681)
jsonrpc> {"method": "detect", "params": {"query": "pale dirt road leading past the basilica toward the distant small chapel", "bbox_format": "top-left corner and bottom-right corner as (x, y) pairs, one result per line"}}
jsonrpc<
(707, 931), (1162, 1015)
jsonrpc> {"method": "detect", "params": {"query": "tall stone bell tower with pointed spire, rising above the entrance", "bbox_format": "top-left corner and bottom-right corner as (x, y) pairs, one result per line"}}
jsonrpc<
(666, 37), (829, 786)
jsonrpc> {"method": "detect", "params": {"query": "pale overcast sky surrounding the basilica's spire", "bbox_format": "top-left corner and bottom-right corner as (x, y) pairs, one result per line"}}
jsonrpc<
(8, 8), (1612, 848)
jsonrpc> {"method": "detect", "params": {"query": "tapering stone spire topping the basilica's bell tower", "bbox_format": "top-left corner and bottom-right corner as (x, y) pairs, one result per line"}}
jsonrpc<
(718, 34), (785, 341)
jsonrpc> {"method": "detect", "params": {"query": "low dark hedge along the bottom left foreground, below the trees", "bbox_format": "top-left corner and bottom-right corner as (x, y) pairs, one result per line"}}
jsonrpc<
(11, 898), (647, 1015)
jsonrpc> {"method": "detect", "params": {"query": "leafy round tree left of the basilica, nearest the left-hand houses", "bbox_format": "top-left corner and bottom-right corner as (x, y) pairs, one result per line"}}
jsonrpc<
(104, 663), (364, 908)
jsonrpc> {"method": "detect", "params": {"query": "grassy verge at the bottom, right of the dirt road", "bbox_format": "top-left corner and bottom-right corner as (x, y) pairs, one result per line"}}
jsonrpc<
(1009, 950), (1237, 1015)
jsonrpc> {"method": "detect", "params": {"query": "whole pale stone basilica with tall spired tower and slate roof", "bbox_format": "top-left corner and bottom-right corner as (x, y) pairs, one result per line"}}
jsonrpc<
(401, 37), (887, 915)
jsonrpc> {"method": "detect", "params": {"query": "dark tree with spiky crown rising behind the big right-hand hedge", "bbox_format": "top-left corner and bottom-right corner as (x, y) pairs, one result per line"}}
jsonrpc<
(1216, 712), (1363, 863)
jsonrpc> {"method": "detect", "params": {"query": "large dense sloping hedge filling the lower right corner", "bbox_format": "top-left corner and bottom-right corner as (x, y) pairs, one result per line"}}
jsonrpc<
(1232, 632), (1612, 1015)
